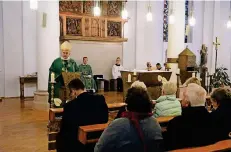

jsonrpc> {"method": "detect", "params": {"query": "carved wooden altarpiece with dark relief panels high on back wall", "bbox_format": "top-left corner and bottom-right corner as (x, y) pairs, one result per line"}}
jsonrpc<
(59, 1), (127, 42)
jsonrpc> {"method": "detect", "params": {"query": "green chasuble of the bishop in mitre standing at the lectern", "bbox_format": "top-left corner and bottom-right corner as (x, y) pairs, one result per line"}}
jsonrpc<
(48, 58), (79, 102)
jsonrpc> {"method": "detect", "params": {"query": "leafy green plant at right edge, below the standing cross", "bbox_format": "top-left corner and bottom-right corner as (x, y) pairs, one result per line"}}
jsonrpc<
(212, 67), (231, 88)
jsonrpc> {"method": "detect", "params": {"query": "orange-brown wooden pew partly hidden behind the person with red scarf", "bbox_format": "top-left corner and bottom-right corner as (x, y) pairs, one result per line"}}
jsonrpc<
(78, 117), (174, 145)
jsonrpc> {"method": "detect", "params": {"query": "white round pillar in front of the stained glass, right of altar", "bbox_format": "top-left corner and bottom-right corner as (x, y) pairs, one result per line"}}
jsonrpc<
(167, 0), (185, 82)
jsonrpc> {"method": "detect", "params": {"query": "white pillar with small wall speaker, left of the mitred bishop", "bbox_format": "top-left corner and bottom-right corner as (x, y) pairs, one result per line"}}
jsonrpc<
(34, 1), (60, 110)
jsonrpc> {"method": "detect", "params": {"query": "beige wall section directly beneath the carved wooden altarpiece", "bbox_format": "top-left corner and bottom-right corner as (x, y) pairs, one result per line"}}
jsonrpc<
(71, 41), (123, 79)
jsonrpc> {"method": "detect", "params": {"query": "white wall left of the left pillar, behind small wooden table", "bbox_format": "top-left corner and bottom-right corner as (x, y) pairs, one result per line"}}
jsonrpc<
(0, 1), (36, 97)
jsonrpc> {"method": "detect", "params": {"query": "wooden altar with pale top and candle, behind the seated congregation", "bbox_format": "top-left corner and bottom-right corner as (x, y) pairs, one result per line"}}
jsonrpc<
(121, 70), (172, 100)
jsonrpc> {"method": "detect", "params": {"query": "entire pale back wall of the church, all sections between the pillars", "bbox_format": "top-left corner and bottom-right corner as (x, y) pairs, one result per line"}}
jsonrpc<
(0, 0), (231, 97)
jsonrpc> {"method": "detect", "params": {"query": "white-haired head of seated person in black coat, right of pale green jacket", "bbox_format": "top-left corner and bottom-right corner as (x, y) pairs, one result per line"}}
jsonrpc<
(184, 83), (206, 107)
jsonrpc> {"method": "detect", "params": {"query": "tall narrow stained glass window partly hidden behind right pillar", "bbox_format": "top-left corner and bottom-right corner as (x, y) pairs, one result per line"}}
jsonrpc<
(163, 0), (189, 43)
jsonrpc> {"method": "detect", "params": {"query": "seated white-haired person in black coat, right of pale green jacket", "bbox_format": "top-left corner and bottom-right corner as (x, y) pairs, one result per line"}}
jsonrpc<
(164, 83), (213, 150)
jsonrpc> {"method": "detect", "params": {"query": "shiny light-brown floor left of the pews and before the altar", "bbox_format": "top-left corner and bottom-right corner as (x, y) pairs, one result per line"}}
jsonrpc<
(0, 92), (123, 152)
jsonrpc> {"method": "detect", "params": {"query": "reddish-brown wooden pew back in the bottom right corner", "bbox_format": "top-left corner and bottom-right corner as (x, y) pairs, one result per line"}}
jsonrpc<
(171, 139), (231, 152)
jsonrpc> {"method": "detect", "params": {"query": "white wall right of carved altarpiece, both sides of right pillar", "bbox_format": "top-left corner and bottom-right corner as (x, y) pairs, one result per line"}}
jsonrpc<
(123, 1), (231, 79)
